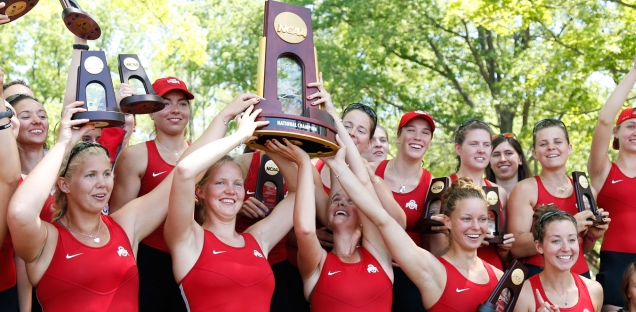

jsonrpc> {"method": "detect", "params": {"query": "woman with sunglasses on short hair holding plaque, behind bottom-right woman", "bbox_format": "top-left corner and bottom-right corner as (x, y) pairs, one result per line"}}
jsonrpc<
(508, 119), (609, 276)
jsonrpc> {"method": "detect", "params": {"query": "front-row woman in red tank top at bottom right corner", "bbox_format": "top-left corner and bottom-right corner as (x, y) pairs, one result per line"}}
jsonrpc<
(515, 204), (603, 312)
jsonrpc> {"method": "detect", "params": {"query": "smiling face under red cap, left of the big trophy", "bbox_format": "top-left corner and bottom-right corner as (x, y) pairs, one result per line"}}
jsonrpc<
(150, 90), (190, 135)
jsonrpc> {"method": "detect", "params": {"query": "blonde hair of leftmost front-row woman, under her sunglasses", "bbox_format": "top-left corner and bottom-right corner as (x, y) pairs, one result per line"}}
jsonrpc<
(51, 146), (110, 222)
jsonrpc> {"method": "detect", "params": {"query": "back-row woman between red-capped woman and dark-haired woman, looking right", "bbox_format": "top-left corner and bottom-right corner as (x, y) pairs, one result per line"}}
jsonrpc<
(450, 119), (514, 270)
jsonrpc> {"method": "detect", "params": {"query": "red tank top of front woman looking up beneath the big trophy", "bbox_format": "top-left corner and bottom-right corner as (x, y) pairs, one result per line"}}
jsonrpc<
(309, 247), (393, 312)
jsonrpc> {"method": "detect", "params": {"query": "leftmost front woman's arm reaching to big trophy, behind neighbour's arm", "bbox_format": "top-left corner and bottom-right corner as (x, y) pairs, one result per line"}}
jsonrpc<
(111, 94), (261, 246)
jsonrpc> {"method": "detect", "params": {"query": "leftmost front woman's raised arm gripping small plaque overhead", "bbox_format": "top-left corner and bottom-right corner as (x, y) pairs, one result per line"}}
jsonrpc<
(7, 102), (95, 263)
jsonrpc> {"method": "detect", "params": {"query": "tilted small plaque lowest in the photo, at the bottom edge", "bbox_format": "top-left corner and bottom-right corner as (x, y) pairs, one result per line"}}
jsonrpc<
(477, 259), (528, 312)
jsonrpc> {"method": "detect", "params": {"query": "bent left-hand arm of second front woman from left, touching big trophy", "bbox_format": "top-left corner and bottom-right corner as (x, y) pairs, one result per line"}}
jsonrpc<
(164, 107), (265, 260)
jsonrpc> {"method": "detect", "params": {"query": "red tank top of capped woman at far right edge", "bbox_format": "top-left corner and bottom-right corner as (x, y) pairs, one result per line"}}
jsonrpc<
(597, 163), (636, 254)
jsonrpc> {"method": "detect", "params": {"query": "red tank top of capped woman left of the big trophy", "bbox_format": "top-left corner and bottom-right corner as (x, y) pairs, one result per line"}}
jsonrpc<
(137, 141), (174, 253)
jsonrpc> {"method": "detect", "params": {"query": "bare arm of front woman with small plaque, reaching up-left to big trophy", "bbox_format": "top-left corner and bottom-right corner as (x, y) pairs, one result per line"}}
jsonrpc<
(325, 137), (446, 291)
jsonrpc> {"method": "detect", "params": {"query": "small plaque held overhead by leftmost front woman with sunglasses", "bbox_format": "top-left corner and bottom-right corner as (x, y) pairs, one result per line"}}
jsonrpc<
(73, 51), (125, 128)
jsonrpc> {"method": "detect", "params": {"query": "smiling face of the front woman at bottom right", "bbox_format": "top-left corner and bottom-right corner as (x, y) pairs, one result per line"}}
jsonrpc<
(534, 220), (579, 271)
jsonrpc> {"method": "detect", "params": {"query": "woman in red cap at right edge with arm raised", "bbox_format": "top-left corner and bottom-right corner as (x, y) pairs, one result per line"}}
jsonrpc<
(587, 58), (636, 309)
